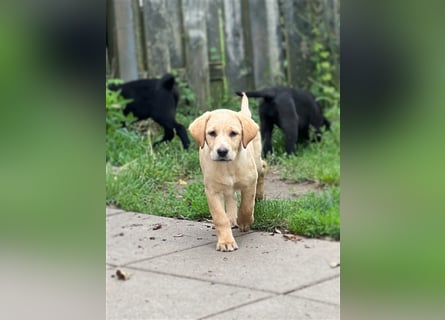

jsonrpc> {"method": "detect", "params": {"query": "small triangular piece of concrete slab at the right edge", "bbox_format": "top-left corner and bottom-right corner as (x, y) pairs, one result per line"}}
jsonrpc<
(290, 277), (340, 305)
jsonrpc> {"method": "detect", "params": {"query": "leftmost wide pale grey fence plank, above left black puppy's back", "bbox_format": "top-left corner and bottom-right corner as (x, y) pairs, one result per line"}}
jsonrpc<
(112, 0), (138, 81)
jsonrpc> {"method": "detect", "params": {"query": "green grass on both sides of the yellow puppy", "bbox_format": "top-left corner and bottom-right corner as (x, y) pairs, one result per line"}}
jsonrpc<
(106, 82), (340, 239)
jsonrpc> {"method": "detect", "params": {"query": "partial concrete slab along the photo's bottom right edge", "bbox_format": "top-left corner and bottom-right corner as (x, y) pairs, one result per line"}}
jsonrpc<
(206, 296), (340, 320)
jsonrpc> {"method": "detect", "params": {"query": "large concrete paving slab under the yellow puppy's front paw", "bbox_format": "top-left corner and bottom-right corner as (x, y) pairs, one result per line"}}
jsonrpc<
(129, 229), (340, 293)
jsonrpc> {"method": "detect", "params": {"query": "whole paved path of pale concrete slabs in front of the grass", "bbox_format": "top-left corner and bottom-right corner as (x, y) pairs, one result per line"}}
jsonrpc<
(106, 208), (340, 320)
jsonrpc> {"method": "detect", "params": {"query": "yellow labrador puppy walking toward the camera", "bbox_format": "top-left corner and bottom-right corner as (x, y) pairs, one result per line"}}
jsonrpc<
(189, 94), (266, 251)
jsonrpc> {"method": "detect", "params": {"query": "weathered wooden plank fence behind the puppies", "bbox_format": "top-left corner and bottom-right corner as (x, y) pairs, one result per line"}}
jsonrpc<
(106, 0), (340, 109)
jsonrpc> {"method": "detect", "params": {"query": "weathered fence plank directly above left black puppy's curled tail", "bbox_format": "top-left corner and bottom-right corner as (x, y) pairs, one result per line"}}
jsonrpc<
(144, 0), (171, 78)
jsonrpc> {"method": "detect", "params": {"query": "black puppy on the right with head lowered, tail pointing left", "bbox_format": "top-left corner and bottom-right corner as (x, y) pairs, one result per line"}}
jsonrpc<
(236, 87), (331, 156)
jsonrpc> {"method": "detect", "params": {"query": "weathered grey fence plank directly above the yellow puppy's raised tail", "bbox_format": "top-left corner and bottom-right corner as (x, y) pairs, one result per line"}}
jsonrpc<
(223, 0), (251, 94)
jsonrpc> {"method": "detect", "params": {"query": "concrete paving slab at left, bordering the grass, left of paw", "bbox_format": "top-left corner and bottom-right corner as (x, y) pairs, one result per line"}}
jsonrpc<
(106, 212), (253, 265)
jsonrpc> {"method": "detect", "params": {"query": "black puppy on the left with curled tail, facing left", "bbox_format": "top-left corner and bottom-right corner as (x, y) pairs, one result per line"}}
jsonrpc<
(108, 73), (190, 149)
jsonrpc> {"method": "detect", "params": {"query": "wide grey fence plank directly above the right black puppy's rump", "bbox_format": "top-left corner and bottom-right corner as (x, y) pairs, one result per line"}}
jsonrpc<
(245, 0), (283, 88)
